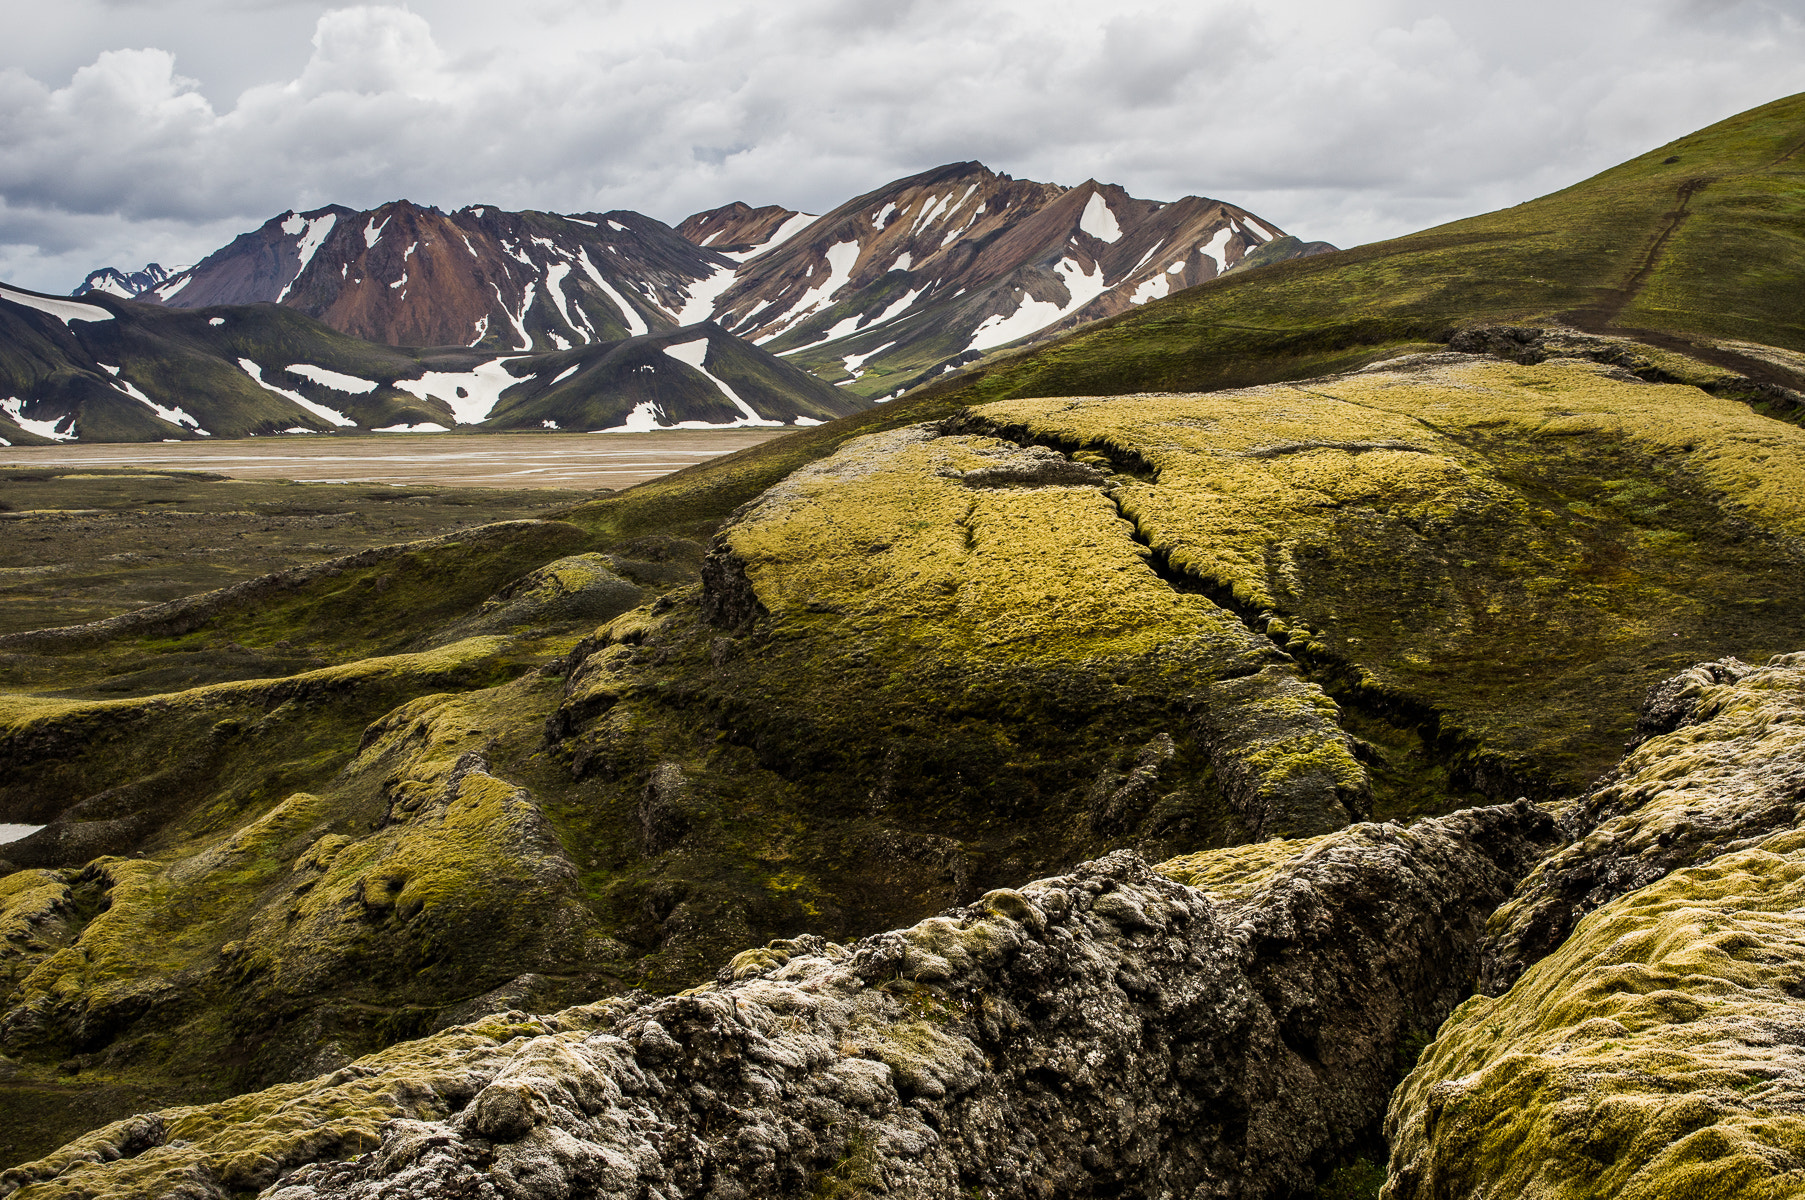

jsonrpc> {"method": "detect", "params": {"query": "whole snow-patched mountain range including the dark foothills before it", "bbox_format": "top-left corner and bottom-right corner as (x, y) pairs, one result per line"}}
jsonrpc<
(0, 162), (1332, 444)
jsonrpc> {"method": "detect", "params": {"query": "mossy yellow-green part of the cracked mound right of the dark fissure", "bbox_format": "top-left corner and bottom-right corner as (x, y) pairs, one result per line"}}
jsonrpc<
(969, 357), (1805, 794)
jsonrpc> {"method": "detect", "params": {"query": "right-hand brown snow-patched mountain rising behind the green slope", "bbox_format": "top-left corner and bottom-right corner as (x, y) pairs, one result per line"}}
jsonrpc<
(677, 162), (1334, 397)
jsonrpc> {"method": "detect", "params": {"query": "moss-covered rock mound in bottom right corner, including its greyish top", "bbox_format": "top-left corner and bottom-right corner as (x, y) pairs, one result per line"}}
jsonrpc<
(1384, 655), (1805, 1200)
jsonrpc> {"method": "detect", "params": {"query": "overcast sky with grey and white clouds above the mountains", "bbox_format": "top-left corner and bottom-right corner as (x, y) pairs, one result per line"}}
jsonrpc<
(0, 0), (1805, 292)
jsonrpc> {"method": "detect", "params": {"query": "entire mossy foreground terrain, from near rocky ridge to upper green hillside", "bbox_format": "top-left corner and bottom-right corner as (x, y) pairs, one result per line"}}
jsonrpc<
(10, 88), (1805, 1200)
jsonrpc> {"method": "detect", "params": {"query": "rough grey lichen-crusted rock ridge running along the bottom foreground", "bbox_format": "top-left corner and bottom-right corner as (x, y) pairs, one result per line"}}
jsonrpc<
(0, 803), (1552, 1200)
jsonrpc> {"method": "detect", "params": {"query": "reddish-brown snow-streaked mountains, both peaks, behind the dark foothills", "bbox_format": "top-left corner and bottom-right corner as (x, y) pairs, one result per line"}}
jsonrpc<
(85, 162), (1334, 399)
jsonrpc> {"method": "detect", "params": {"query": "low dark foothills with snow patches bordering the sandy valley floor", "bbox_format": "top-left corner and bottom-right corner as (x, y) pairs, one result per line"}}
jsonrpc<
(0, 287), (861, 446)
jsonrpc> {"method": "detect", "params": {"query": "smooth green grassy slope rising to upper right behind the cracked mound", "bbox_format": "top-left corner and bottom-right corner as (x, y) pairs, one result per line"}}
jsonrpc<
(559, 96), (1805, 534)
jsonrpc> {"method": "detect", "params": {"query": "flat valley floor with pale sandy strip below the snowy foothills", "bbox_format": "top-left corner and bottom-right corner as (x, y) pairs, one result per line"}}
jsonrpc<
(0, 429), (782, 633)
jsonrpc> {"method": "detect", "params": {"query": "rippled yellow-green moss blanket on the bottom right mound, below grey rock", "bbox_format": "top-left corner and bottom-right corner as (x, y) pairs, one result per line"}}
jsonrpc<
(1386, 832), (1805, 1200)
